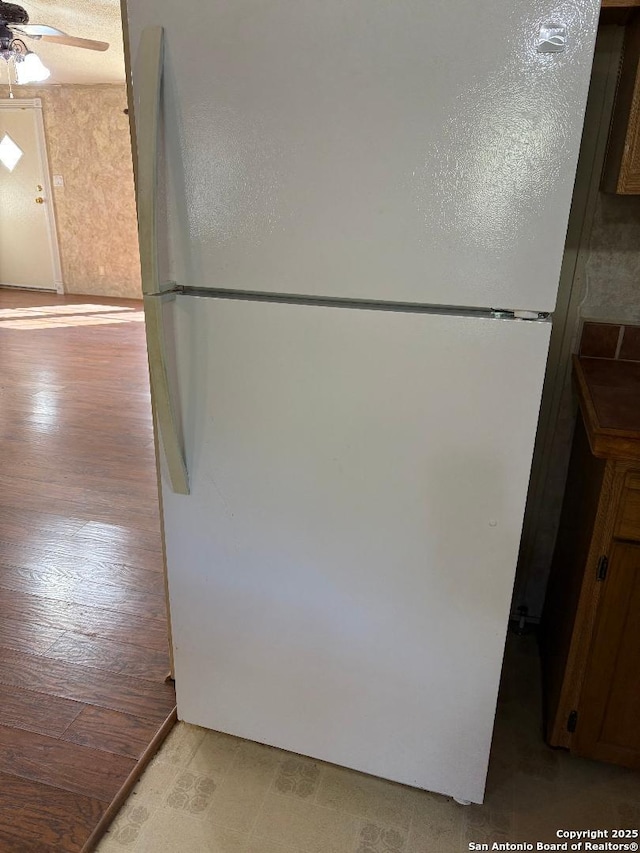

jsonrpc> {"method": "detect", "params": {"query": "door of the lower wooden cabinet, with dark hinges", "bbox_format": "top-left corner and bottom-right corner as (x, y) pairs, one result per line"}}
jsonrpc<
(571, 543), (640, 768)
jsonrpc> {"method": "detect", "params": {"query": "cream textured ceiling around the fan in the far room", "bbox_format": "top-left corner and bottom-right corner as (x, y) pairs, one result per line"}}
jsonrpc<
(6, 0), (125, 86)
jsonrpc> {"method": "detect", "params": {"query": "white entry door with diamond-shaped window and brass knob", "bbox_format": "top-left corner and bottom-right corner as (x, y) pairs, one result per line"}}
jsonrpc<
(0, 99), (62, 290)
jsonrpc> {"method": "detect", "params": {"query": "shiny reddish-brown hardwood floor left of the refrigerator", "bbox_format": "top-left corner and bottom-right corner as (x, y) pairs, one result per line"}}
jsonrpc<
(0, 289), (175, 853)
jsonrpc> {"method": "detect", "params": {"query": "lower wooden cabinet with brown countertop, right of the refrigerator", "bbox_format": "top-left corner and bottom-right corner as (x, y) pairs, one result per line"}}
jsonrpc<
(541, 359), (640, 769)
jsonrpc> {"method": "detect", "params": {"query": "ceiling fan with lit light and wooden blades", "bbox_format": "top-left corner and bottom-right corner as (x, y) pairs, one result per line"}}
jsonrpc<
(0, 0), (109, 83)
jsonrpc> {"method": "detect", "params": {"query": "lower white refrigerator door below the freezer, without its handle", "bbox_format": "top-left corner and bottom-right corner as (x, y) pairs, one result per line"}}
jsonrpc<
(163, 296), (549, 802)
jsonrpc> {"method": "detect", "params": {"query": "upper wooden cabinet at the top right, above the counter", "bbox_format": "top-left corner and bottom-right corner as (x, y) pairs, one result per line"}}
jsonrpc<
(602, 12), (640, 195)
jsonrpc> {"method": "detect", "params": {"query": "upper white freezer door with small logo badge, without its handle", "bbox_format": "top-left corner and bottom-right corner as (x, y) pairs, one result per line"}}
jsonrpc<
(126, 0), (600, 311)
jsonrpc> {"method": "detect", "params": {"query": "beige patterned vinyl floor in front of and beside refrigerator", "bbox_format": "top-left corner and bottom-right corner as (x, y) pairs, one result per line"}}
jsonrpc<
(98, 635), (640, 853)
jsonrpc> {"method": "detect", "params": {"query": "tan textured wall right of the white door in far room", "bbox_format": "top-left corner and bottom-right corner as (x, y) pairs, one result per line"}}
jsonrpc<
(0, 84), (141, 297)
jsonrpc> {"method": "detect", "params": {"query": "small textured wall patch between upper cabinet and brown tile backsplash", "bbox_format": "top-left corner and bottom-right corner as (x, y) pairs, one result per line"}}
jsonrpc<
(581, 193), (640, 323)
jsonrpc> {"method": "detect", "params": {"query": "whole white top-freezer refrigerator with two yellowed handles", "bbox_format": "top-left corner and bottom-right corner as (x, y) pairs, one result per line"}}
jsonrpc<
(126, 0), (599, 802)
